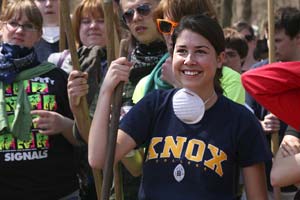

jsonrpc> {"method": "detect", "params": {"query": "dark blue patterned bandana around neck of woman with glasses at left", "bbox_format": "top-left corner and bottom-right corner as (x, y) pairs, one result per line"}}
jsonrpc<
(0, 43), (39, 84)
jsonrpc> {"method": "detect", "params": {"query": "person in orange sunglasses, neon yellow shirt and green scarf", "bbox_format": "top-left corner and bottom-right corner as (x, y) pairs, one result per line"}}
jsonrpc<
(132, 0), (245, 104)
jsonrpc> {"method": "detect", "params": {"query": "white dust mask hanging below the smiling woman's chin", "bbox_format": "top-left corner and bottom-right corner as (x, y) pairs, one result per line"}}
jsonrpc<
(173, 88), (215, 124)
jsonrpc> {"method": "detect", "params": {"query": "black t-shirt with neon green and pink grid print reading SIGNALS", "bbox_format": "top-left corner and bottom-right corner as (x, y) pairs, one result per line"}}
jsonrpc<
(0, 68), (77, 200)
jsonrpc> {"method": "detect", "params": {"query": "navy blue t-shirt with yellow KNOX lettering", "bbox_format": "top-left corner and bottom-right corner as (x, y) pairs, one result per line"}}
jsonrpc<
(120, 89), (271, 200)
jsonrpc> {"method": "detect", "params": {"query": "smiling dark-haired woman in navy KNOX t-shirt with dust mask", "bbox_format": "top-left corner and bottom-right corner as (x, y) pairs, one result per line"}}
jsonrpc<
(84, 15), (271, 200)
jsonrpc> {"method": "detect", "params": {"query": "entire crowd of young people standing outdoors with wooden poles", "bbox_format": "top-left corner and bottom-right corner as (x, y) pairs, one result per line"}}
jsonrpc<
(0, 0), (300, 200)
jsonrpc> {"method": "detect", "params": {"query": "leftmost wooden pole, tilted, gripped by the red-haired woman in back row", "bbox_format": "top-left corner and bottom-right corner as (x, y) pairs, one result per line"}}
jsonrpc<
(60, 0), (102, 199)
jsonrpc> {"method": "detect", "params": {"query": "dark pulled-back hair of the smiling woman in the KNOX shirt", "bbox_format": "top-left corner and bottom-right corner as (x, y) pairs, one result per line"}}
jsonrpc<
(172, 15), (225, 94)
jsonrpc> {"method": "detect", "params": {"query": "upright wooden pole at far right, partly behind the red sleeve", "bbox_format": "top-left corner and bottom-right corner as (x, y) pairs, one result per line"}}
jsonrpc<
(268, 0), (280, 200)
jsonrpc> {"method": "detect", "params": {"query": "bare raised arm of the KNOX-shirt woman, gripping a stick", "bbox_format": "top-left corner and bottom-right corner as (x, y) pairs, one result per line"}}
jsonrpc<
(88, 57), (136, 168)
